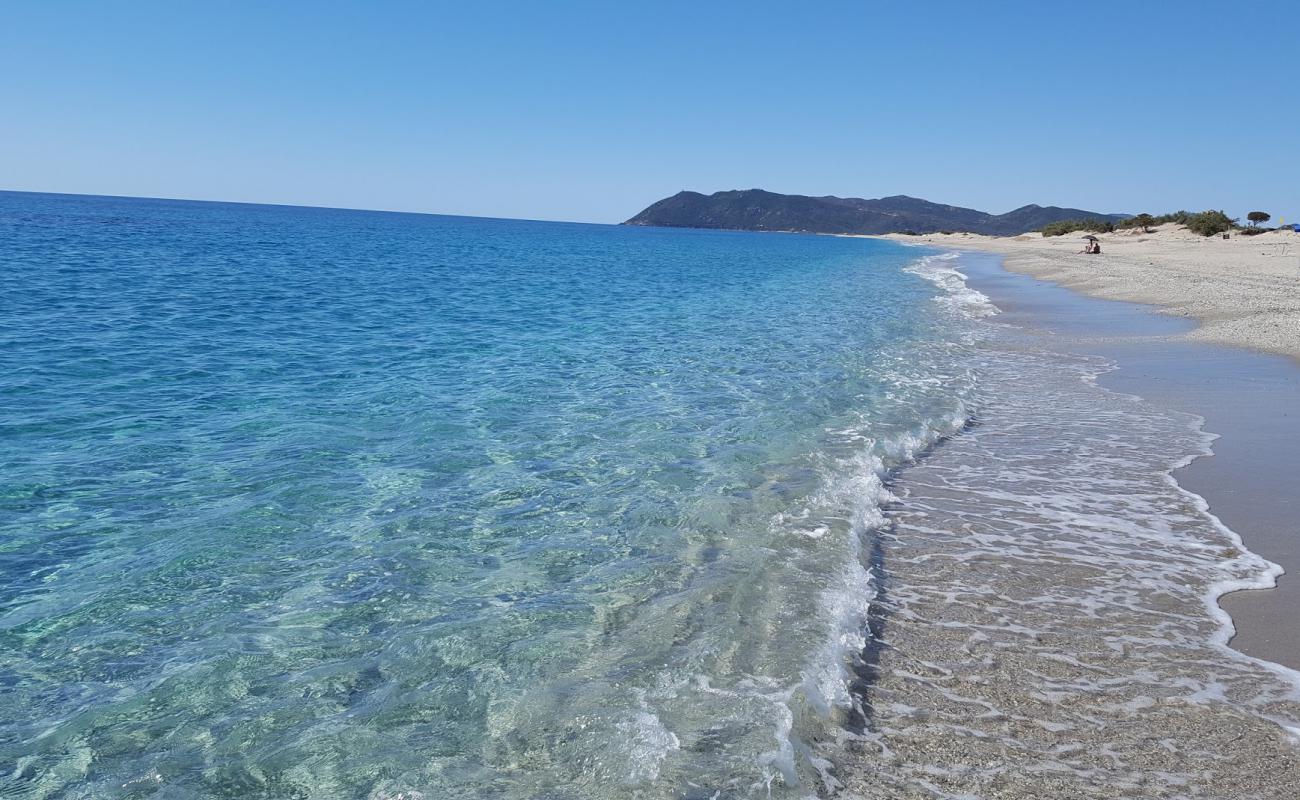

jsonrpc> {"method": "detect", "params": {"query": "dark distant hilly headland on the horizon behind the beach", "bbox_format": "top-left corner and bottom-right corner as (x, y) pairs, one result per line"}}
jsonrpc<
(624, 189), (1127, 235)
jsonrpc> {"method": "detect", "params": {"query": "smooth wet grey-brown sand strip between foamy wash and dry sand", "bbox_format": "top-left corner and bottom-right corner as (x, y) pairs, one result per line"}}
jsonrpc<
(946, 247), (1300, 670)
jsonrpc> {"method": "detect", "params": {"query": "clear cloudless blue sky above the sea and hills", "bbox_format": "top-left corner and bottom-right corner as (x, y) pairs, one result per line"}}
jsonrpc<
(0, 0), (1300, 222)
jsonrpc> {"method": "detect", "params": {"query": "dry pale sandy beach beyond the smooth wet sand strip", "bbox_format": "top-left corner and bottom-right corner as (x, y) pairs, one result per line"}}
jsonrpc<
(884, 224), (1300, 360)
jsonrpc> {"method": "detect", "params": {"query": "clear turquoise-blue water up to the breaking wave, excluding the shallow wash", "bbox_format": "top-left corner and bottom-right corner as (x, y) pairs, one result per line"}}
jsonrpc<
(0, 194), (971, 799)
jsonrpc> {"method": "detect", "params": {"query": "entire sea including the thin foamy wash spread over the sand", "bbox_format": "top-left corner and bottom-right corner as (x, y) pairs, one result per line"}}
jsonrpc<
(0, 193), (1300, 800)
